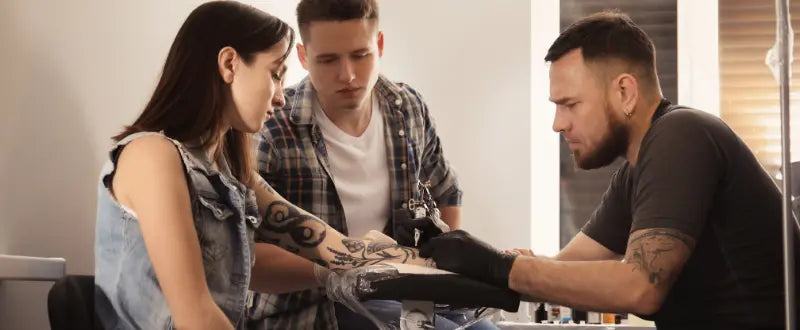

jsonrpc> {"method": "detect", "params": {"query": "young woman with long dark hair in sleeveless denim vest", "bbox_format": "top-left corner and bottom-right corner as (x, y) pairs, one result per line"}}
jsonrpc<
(95, 1), (429, 329)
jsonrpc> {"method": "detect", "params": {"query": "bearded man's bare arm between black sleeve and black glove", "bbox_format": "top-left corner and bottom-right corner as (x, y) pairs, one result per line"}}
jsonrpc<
(509, 228), (695, 314)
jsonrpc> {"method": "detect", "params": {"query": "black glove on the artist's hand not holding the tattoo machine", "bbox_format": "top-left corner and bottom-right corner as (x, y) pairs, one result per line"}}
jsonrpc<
(419, 230), (517, 288)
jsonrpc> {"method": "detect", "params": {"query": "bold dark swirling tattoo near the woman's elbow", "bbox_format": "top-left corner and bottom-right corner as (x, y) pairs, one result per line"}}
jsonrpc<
(260, 201), (327, 251)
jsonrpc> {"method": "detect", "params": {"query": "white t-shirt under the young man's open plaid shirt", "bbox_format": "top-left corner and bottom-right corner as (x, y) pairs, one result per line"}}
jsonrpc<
(314, 95), (389, 238)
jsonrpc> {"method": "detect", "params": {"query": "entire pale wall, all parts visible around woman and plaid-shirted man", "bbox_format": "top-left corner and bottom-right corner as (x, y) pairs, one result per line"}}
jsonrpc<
(0, 0), (536, 330)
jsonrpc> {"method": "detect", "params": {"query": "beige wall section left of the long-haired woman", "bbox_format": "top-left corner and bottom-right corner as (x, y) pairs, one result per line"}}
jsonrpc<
(0, 0), (206, 330)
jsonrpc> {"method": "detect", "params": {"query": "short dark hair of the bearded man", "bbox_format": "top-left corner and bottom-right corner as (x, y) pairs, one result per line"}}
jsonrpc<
(544, 10), (657, 85)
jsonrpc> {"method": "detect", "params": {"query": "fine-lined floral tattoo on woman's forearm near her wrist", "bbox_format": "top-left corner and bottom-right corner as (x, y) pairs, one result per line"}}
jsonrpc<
(328, 238), (418, 267)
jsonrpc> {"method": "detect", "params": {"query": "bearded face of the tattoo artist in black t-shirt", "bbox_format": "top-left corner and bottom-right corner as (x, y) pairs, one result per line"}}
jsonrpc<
(550, 49), (628, 169)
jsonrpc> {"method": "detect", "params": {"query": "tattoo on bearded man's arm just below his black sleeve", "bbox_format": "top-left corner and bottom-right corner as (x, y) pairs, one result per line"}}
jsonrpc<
(625, 229), (695, 285)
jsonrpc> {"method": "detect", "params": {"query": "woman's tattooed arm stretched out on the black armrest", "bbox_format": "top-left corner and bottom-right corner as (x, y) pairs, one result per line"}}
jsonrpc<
(251, 176), (433, 270)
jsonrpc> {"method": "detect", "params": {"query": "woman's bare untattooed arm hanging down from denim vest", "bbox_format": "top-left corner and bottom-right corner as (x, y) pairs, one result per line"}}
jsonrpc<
(112, 136), (233, 329)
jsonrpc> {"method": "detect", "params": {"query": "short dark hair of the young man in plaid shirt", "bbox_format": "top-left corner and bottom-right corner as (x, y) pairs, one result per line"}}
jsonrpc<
(297, 0), (378, 42)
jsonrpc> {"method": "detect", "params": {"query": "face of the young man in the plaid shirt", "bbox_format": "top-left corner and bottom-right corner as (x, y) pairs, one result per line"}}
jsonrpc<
(297, 19), (383, 111)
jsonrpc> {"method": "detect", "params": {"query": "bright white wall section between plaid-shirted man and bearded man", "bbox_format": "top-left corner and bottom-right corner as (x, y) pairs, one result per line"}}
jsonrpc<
(381, 0), (536, 248)
